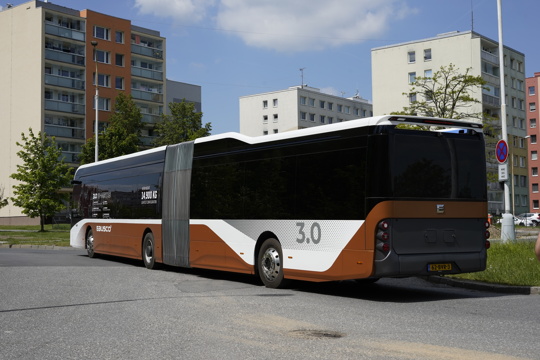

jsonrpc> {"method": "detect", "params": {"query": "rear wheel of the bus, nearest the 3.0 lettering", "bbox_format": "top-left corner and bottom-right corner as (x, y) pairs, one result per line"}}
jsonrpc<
(257, 239), (287, 289)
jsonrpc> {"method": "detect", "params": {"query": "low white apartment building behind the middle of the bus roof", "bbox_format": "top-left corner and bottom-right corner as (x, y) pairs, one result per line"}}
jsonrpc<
(240, 85), (373, 136)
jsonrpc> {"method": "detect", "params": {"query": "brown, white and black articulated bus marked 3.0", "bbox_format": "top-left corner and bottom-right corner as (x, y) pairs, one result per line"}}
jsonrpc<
(70, 116), (489, 288)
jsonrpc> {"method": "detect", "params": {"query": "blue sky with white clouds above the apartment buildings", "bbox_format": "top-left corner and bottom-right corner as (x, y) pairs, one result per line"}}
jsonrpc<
(0, 0), (540, 134)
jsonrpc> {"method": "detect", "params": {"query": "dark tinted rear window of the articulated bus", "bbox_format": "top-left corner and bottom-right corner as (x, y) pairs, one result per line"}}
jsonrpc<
(390, 133), (487, 200)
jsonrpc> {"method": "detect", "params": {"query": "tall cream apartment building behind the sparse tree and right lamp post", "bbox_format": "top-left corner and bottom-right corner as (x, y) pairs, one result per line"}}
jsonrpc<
(371, 31), (529, 214)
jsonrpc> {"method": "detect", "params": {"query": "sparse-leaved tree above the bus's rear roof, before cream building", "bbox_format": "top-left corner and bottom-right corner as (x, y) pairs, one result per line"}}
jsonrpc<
(395, 64), (486, 119)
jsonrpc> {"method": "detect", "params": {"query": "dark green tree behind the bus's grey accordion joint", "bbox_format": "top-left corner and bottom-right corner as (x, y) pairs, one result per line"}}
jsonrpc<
(154, 99), (212, 146)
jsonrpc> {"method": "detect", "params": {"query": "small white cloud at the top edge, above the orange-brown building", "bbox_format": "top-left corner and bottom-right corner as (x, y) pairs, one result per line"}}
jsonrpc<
(135, 0), (215, 24)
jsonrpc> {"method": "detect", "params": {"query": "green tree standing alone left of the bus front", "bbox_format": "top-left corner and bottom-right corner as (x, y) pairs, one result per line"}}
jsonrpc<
(11, 129), (72, 231)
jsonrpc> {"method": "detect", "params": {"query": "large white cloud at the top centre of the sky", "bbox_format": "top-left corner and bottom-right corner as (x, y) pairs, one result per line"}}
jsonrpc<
(217, 0), (411, 52)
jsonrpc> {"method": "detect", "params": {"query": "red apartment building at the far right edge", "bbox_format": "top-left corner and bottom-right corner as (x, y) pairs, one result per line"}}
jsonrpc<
(525, 72), (540, 212)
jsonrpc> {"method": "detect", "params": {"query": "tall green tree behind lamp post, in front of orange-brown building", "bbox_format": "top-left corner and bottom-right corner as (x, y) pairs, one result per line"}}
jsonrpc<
(79, 92), (143, 164)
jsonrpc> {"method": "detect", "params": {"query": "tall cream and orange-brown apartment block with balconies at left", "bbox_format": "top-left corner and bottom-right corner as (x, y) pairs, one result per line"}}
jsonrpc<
(0, 1), (200, 223)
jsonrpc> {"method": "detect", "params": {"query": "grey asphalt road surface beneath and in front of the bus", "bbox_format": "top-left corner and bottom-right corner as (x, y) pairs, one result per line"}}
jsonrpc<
(0, 249), (540, 360)
